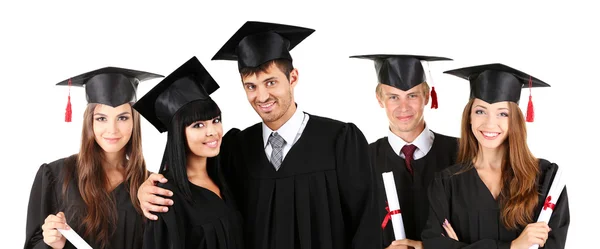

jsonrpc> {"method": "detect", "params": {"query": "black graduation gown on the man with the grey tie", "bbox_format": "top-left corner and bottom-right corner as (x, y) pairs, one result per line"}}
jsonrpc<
(221, 115), (381, 249)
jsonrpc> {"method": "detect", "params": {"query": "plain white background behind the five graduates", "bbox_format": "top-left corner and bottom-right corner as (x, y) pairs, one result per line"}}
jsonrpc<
(0, 1), (600, 248)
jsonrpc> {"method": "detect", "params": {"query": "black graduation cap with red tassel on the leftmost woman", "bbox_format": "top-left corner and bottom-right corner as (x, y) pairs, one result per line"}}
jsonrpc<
(56, 67), (164, 122)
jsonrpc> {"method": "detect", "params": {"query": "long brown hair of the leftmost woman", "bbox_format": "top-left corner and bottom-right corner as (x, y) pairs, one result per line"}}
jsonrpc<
(62, 103), (148, 248)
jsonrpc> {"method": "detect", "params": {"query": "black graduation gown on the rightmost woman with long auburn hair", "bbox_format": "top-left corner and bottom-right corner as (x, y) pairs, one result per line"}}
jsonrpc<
(422, 159), (570, 249)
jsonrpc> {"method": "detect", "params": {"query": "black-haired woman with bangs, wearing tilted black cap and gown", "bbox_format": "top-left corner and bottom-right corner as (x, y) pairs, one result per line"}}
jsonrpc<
(134, 57), (243, 249)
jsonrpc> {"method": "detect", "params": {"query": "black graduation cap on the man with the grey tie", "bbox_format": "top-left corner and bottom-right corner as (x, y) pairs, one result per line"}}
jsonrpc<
(212, 21), (315, 70)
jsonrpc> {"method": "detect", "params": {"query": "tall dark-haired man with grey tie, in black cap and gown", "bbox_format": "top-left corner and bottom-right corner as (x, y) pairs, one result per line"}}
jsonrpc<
(213, 22), (380, 249)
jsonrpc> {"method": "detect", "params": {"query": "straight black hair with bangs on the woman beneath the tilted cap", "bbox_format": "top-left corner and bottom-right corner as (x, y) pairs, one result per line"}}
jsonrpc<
(158, 98), (224, 202)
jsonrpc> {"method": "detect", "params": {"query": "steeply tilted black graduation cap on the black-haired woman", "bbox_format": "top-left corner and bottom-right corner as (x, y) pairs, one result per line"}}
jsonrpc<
(133, 56), (219, 133)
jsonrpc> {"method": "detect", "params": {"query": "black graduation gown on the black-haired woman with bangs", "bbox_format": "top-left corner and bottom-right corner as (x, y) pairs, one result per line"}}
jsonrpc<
(144, 174), (244, 249)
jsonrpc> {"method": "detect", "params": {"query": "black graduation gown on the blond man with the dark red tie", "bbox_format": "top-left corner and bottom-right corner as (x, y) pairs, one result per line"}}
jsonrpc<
(369, 133), (458, 248)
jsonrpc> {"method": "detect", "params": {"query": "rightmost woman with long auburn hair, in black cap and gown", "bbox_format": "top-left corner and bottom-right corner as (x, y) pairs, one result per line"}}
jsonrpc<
(422, 64), (570, 249)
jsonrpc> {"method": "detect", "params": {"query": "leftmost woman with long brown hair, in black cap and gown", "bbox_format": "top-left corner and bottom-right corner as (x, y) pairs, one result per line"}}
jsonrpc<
(25, 67), (162, 249)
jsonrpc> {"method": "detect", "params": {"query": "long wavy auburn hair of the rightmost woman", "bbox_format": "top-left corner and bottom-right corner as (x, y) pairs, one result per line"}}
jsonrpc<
(457, 98), (539, 229)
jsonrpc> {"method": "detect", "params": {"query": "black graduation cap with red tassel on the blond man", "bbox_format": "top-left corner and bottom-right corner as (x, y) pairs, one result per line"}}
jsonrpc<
(350, 54), (452, 109)
